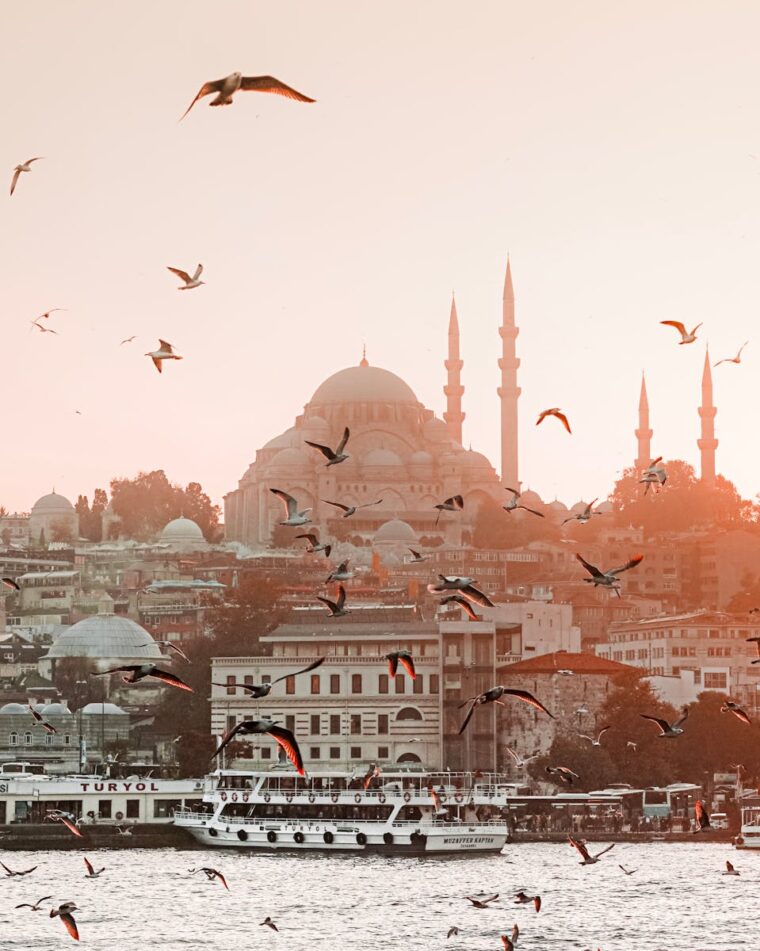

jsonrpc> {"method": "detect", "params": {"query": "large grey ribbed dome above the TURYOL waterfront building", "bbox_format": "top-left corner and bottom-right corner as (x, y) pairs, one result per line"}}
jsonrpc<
(46, 614), (161, 660)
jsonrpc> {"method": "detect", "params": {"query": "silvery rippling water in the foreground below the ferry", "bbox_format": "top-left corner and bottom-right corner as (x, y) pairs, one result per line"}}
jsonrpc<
(0, 842), (760, 951)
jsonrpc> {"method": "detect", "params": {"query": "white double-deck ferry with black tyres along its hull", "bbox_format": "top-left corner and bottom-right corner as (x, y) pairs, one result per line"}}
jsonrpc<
(174, 768), (514, 855)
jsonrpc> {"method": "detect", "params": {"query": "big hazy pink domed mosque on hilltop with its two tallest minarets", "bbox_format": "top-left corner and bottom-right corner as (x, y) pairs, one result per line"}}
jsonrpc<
(224, 263), (520, 549)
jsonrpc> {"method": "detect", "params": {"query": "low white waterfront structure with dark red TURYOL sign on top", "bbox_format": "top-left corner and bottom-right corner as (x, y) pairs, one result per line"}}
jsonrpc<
(0, 762), (203, 825)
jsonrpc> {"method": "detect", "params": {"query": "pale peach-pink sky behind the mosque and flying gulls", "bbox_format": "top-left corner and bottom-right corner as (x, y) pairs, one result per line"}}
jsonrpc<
(0, 0), (760, 511)
